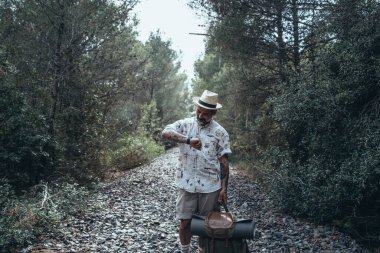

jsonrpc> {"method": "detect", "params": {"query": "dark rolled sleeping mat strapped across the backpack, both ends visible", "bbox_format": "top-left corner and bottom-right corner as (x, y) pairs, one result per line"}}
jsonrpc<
(190, 215), (256, 239)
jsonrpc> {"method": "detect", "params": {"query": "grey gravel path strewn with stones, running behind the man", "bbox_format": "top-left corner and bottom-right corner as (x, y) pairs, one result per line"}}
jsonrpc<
(32, 149), (368, 253)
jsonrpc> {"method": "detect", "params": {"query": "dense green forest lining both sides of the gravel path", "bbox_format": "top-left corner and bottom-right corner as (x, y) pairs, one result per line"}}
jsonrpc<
(0, 0), (380, 249)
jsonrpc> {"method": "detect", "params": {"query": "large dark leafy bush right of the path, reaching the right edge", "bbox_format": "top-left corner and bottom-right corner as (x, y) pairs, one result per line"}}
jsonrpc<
(268, 75), (380, 238)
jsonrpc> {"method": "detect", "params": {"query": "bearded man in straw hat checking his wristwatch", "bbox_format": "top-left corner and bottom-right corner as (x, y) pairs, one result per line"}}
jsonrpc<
(162, 90), (231, 253)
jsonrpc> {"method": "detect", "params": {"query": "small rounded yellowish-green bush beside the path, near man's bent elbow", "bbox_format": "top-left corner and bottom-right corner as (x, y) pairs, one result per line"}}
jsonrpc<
(104, 132), (164, 170)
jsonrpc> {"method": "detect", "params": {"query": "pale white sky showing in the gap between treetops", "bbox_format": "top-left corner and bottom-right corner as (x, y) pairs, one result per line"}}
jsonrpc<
(134, 0), (205, 81)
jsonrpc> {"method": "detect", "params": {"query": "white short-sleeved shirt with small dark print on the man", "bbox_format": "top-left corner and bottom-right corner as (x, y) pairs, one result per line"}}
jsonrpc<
(165, 117), (231, 193)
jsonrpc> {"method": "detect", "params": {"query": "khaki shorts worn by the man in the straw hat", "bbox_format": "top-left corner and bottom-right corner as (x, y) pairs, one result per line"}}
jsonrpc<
(176, 189), (220, 220)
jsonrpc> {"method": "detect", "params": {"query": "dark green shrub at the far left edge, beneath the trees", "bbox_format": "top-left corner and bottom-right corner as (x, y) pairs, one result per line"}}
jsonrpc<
(0, 52), (54, 189)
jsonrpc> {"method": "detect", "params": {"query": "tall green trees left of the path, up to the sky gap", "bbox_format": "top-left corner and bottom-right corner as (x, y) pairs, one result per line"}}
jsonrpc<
(0, 0), (187, 188)
